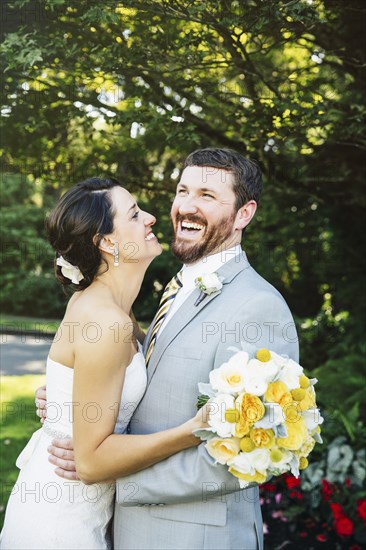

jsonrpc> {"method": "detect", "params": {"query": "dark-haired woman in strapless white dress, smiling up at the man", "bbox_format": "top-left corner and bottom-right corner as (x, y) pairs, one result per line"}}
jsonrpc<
(1, 178), (205, 550)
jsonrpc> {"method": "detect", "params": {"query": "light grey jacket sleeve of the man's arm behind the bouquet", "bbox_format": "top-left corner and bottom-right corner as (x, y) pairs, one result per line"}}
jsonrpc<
(117, 292), (298, 506)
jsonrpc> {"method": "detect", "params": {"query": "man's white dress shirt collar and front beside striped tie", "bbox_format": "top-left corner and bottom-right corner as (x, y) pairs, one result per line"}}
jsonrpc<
(157, 244), (242, 338)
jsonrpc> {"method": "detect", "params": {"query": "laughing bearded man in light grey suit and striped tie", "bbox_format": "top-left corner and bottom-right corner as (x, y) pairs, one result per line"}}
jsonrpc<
(36, 148), (298, 550)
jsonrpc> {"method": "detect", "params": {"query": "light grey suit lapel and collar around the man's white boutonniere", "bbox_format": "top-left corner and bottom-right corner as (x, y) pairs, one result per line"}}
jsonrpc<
(144, 251), (249, 383)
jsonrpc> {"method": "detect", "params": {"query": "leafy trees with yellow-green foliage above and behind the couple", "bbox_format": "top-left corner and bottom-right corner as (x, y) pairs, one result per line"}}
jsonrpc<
(1, 0), (366, 348)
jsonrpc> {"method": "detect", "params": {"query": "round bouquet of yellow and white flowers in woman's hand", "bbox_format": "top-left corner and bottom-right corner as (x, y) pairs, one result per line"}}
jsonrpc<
(196, 349), (323, 488)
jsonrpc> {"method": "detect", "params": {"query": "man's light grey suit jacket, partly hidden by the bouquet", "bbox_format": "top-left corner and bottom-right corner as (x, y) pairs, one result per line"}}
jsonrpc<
(114, 252), (298, 550)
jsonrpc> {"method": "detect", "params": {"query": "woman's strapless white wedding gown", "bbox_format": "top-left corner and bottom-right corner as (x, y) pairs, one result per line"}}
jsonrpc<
(0, 351), (146, 550)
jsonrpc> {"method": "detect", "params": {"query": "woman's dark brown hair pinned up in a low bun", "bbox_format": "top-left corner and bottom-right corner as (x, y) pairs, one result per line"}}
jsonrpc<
(46, 178), (121, 290)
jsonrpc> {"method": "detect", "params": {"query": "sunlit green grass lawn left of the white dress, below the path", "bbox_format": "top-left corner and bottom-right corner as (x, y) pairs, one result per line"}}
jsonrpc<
(0, 374), (45, 529)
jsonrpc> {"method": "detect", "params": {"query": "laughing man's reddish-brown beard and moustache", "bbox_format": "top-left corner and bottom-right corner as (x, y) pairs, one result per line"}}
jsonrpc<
(171, 212), (236, 264)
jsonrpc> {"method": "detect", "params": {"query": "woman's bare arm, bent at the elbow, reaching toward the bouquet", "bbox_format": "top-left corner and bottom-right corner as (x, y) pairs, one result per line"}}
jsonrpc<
(73, 312), (204, 483)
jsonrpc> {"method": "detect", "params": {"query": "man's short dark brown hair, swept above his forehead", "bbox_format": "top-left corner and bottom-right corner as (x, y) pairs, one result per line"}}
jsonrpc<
(184, 147), (263, 211)
